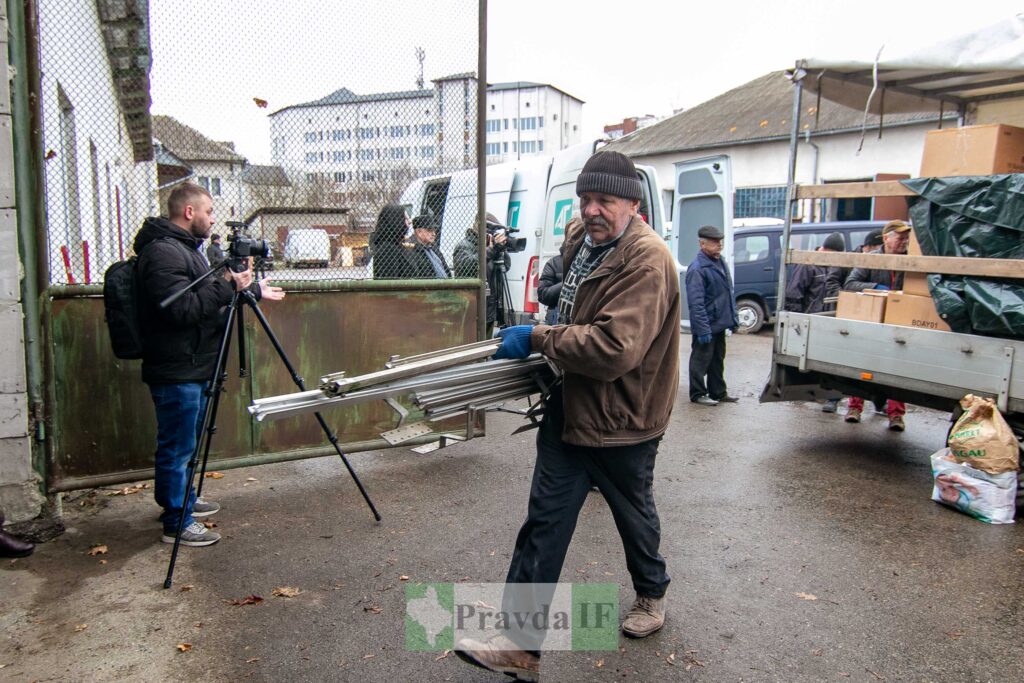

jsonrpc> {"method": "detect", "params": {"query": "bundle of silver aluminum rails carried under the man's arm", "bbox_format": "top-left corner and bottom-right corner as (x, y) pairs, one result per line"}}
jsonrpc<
(249, 350), (557, 422)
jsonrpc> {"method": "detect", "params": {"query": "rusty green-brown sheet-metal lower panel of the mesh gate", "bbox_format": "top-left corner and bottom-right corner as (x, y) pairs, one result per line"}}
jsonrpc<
(45, 283), (479, 492)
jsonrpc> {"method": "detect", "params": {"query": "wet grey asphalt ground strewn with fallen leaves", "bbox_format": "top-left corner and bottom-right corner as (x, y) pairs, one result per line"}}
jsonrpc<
(0, 333), (1024, 683)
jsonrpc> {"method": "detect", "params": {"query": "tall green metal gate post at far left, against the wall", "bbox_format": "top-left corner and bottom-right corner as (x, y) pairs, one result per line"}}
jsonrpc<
(7, 0), (48, 464)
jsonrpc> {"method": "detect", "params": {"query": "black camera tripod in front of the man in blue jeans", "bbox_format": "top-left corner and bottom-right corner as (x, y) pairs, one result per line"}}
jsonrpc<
(160, 258), (381, 589)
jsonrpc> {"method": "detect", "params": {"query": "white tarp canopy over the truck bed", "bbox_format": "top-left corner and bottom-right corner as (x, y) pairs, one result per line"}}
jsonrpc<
(793, 14), (1024, 114)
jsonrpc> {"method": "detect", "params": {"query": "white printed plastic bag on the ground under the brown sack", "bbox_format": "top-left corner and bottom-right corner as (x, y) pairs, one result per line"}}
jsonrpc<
(932, 449), (1017, 524)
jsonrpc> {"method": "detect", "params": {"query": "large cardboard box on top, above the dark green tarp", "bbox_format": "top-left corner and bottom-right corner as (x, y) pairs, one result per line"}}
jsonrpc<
(921, 124), (1024, 178)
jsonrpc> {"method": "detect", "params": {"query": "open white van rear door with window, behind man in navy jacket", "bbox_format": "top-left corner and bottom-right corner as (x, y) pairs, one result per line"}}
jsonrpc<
(670, 155), (732, 328)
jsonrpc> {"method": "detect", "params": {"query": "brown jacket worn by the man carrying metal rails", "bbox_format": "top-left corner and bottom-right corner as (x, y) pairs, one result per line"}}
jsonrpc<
(530, 216), (680, 446)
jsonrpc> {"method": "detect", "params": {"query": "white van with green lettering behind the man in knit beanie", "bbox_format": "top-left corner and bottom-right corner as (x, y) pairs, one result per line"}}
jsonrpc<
(399, 142), (670, 318)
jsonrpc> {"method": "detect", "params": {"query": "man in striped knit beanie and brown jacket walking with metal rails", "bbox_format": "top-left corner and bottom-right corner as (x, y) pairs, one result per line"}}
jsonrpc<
(456, 152), (680, 680)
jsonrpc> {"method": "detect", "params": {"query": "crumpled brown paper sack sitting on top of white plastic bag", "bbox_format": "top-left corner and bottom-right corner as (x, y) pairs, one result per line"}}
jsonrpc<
(946, 393), (1020, 474)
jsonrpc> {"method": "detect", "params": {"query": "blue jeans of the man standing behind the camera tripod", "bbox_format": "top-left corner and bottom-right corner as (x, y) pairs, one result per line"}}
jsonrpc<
(150, 383), (206, 535)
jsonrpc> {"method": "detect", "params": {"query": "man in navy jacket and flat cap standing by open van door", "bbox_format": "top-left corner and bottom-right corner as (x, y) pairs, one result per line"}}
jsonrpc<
(686, 225), (739, 405)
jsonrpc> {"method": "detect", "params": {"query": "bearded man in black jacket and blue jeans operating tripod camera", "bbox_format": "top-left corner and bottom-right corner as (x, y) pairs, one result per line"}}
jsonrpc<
(134, 182), (285, 546)
